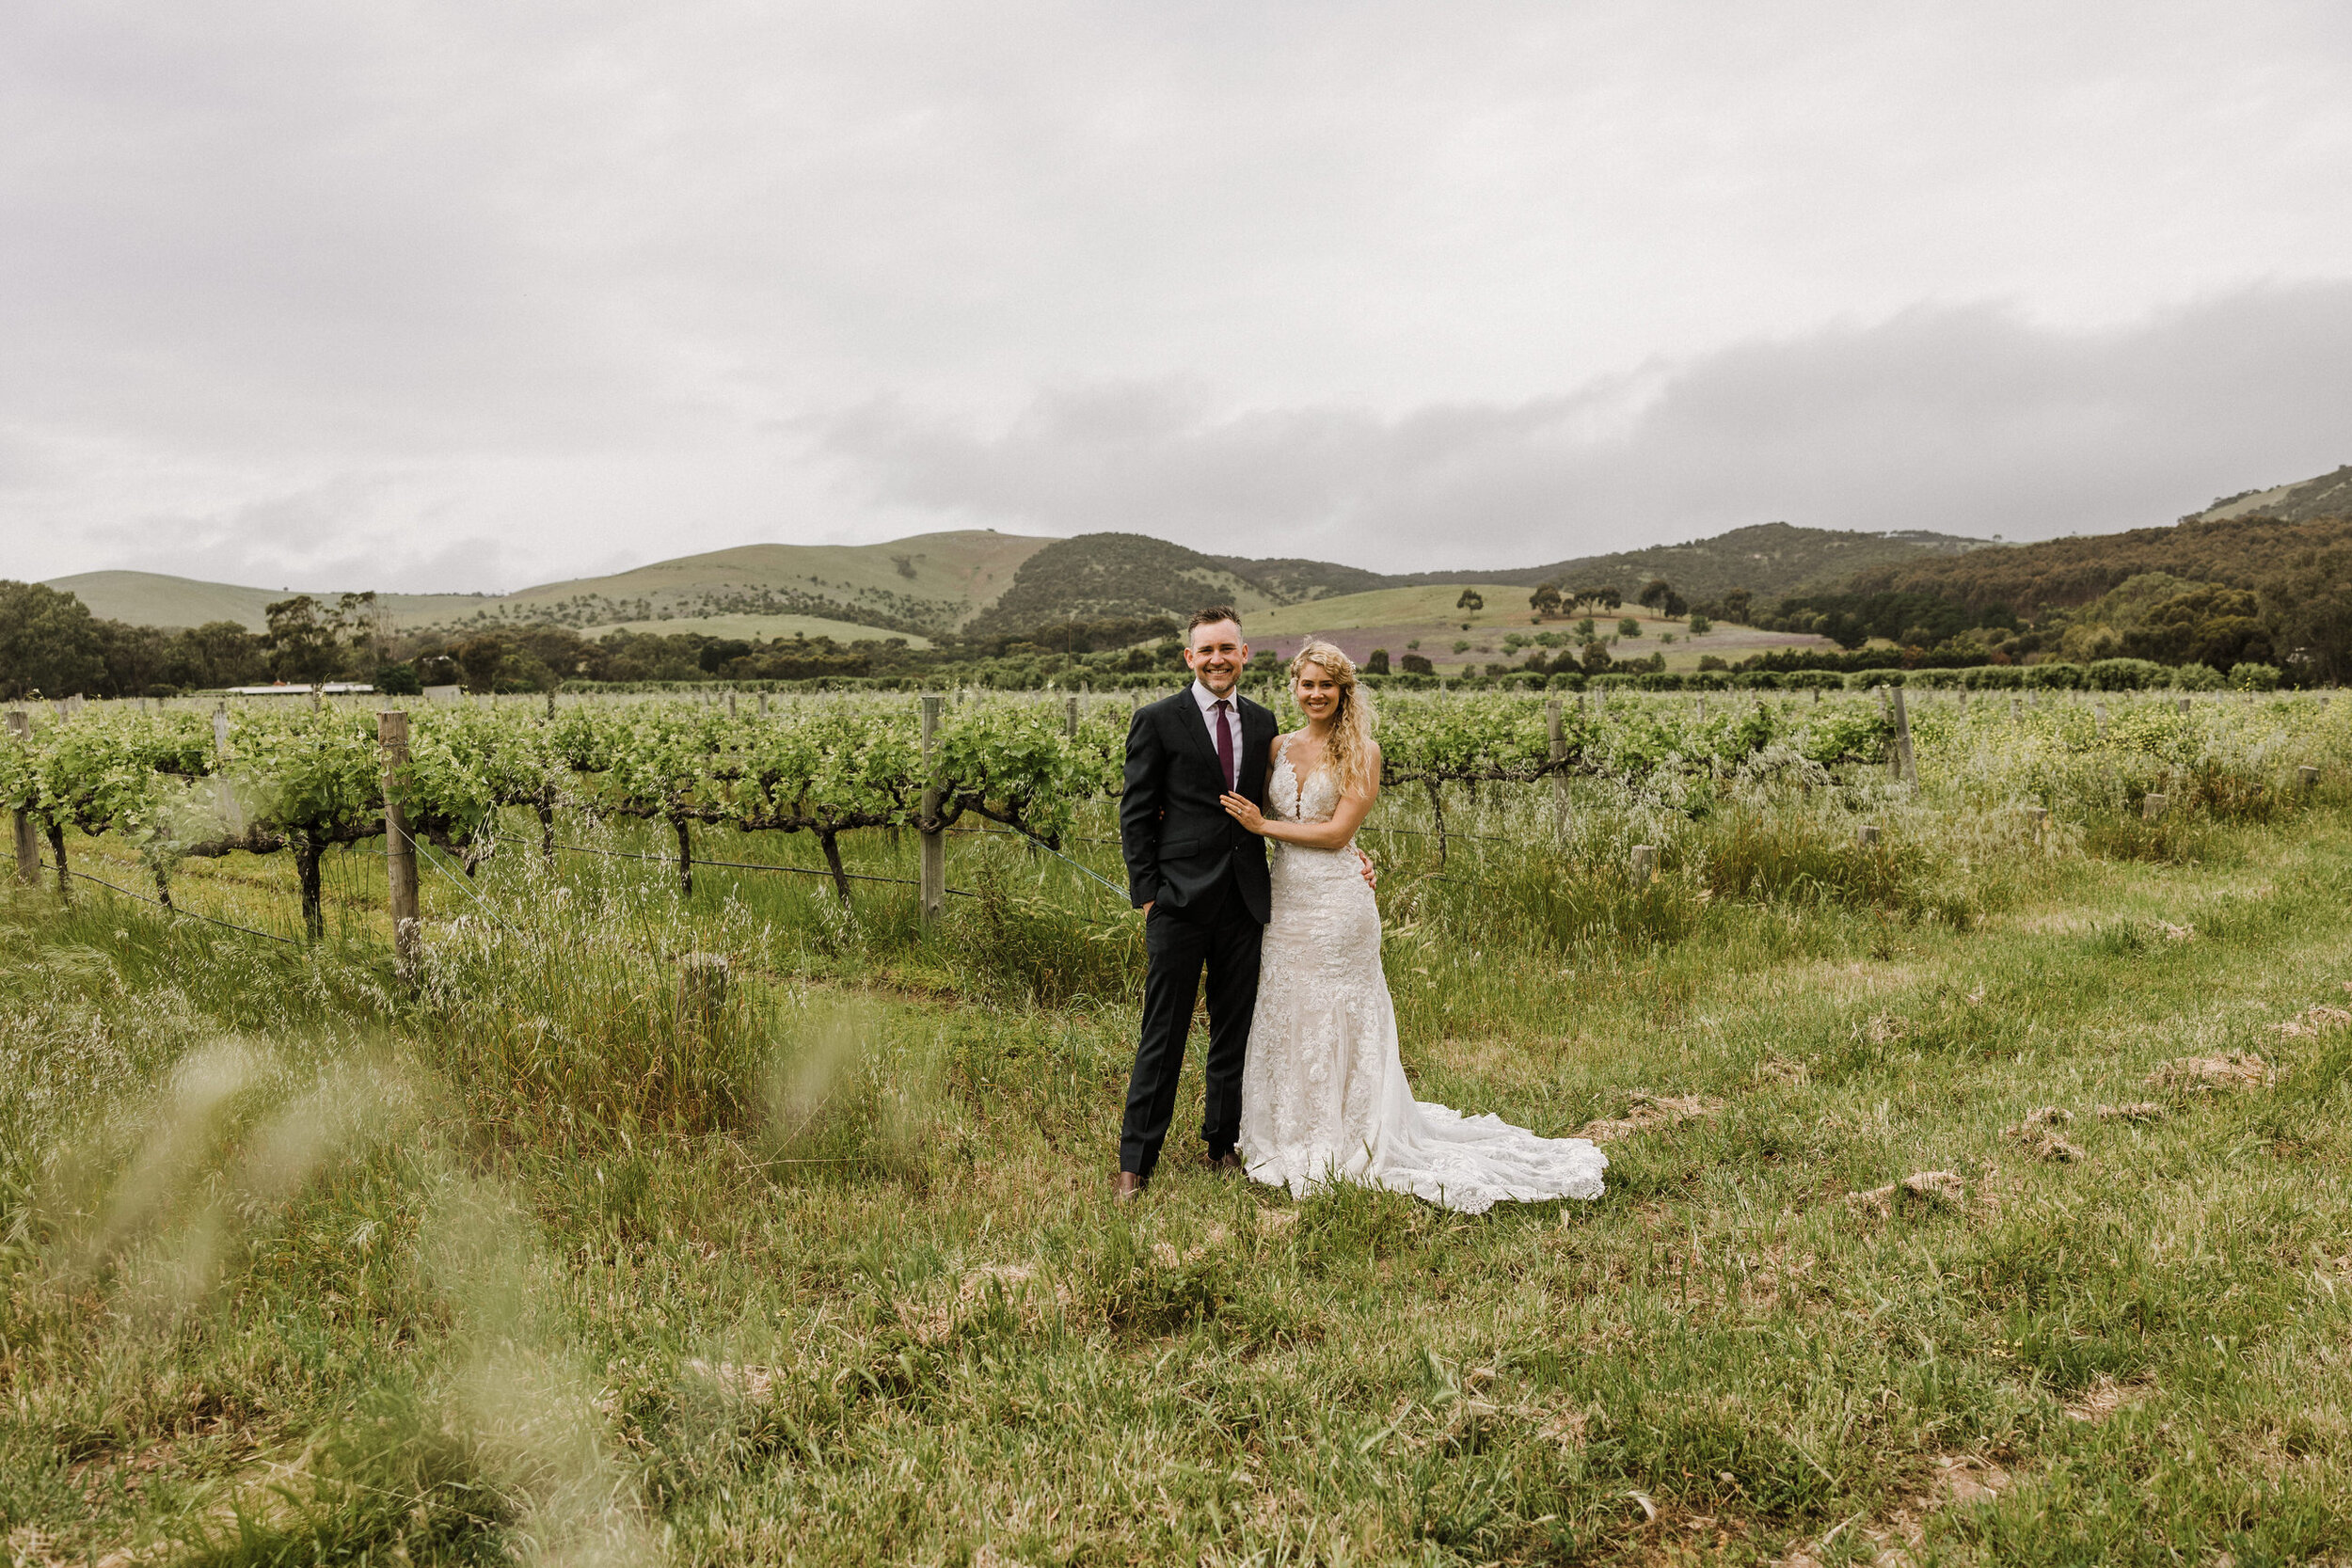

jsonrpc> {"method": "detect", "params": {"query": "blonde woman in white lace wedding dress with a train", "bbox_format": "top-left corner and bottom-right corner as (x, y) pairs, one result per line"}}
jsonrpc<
(1223, 641), (1609, 1213)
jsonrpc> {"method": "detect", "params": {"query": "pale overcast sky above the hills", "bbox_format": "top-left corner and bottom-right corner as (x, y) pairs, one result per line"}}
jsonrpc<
(0, 0), (2352, 590)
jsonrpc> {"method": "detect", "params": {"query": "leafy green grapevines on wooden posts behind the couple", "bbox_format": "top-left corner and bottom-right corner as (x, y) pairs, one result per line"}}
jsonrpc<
(0, 689), (2352, 947)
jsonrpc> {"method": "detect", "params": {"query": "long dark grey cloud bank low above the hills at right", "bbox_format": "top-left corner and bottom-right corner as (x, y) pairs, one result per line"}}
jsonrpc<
(823, 284), (2352, 569)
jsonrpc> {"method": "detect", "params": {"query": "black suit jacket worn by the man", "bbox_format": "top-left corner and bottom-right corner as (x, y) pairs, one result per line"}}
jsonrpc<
(1120, 687), (1279, 927)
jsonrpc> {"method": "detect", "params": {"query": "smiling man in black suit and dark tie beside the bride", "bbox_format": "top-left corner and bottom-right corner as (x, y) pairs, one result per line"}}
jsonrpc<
(1118, 604), (1279, 1201)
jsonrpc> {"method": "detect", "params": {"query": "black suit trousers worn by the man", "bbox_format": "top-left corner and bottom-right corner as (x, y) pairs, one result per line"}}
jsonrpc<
(1120, 872), (1265, 1180)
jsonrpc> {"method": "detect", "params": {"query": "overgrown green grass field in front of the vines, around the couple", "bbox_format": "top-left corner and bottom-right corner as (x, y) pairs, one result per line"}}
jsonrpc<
(0, 728), (2352, 1566)
